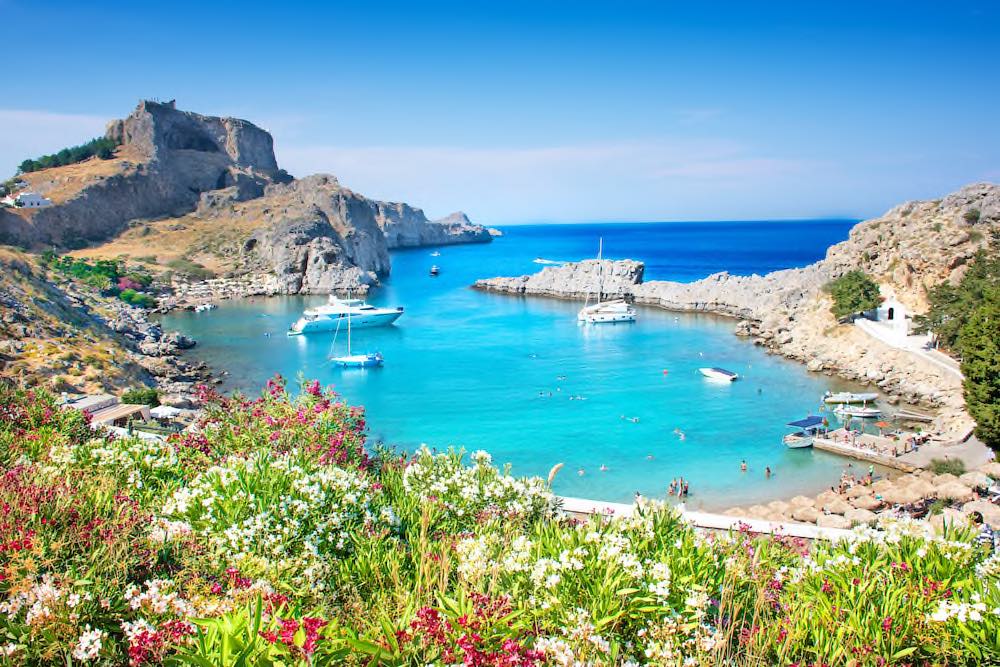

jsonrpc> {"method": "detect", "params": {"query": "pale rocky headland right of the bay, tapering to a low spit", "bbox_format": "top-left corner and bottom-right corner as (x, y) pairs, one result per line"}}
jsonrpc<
(474, 183), (1000, 439)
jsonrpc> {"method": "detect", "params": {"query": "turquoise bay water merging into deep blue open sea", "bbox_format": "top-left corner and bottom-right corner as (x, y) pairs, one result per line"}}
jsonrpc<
(164, 220), (880, 509)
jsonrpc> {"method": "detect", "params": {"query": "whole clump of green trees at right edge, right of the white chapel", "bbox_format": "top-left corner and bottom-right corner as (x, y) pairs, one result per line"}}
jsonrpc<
(915, 233), (1000, 451)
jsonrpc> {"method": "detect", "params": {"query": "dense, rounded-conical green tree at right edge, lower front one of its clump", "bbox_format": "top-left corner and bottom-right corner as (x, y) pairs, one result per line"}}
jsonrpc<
(958, 286), (1000, 451)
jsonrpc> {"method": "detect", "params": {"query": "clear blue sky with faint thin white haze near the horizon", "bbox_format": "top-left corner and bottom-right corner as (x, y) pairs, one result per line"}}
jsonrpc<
(0, 0), (1000, 224)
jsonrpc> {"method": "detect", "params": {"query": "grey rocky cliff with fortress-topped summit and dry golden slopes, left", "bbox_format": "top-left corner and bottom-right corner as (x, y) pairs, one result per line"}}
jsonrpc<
(0, 101), (492, 294)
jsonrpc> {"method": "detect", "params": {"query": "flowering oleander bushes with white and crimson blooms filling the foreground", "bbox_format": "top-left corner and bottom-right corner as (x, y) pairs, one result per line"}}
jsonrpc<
(0, 378), (1000, 667)
